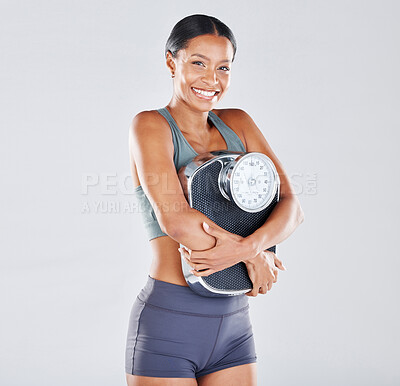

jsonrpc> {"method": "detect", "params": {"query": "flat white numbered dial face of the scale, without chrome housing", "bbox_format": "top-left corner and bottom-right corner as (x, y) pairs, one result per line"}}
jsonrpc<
(231, 154), (275, 211)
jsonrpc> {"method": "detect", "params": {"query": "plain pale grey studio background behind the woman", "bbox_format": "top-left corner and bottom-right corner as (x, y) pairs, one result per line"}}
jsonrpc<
(0, 0), (400, 386)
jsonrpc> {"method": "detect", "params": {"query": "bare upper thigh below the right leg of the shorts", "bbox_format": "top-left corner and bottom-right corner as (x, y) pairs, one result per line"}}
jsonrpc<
(197, 363), (257, 386)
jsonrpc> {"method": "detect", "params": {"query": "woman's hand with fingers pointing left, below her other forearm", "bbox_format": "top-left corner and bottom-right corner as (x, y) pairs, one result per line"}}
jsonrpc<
(179, 222), (254, 276)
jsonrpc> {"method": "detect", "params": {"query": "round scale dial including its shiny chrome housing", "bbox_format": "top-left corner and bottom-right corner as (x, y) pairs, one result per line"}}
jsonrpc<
(220, 152), (279, 212)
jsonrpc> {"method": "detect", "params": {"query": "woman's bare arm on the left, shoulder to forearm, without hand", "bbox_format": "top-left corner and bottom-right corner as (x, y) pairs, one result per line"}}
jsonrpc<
(129, 111), (238, 250)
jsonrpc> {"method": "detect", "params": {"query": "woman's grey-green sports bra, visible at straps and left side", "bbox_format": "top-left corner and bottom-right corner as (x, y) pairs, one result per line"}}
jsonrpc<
(134, 107), (246, 240)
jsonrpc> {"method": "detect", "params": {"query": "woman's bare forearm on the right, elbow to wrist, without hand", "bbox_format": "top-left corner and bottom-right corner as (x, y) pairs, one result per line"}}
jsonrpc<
(244, 195), (304, 256)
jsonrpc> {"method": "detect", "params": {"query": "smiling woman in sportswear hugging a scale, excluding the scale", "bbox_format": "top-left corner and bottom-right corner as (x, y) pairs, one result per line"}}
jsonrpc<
(125, 15), (303, 386)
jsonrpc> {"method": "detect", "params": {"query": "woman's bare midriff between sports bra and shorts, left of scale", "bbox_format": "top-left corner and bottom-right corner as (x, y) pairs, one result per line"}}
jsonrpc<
(149, 236), (188, 287)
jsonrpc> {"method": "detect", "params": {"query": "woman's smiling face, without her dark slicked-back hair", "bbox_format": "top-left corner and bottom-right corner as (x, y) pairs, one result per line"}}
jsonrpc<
(167, 35), (233, 111)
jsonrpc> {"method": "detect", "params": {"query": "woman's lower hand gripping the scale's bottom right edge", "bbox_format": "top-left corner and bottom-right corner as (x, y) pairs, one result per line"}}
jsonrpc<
(244, 250), (286, 296)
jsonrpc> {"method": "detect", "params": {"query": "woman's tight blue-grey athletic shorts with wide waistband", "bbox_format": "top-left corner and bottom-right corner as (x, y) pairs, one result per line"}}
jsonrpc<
(125, 276), (257, 378)
